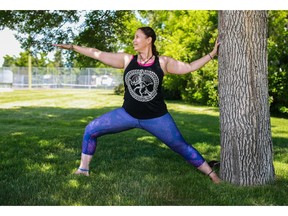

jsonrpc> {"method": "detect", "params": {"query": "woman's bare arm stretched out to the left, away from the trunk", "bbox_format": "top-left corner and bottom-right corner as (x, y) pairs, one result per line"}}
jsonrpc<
(54, 44), (132, 69)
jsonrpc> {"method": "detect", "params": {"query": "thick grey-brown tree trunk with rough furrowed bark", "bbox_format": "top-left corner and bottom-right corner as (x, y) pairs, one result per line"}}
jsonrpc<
(219, 11), (274, 186)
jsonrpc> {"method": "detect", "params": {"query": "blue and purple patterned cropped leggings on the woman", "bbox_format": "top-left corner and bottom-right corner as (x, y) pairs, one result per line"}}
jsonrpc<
(82, 108), (205, 167)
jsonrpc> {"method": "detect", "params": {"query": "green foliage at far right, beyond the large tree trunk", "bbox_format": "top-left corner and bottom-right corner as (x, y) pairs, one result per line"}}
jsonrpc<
(268, 10), (288, 117)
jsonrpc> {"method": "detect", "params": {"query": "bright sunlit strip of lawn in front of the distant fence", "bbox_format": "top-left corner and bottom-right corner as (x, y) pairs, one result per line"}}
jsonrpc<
(0, 89), (123, 109)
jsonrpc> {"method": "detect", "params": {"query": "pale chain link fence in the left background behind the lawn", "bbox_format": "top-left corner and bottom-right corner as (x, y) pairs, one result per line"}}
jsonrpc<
(0, 67), (123, 89)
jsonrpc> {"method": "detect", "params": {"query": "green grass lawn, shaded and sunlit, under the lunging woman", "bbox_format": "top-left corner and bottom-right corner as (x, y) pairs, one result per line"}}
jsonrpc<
(0, 90), (288, 206)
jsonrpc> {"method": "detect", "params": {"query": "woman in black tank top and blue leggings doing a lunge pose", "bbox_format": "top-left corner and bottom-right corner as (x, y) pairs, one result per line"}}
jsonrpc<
(55, 27), (221, 183)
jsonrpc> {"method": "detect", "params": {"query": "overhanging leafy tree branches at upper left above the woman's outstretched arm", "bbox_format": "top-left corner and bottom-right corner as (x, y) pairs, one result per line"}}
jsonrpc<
(0, 10), (135, 67)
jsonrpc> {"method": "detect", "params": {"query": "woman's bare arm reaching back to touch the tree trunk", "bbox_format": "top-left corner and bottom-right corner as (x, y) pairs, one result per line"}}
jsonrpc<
(160, 40), (220, 75)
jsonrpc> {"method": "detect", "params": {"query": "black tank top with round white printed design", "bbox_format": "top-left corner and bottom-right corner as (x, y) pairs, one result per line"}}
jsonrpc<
(123, 56), (167, 119)
